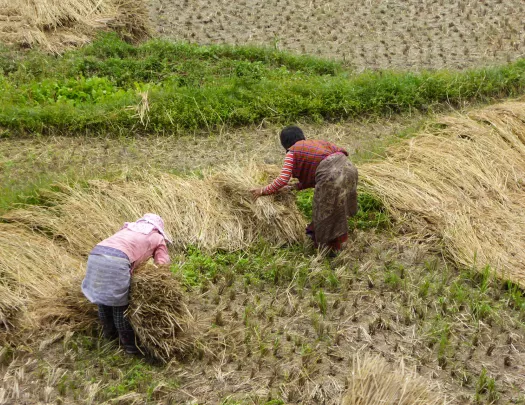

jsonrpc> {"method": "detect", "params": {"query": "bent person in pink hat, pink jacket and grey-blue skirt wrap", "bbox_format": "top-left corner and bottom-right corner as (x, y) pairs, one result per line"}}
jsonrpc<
(82, 214), (170, 354)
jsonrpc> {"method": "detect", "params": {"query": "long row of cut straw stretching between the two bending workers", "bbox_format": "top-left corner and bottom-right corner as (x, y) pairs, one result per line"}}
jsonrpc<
(4, 164), (305, 255)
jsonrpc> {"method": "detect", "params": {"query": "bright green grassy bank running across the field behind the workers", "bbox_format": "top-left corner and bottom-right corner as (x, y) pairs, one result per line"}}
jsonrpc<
(0, 34), (525, 136)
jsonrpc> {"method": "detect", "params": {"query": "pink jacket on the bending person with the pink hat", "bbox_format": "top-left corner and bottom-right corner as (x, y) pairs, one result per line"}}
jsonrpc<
(99, 228), (170, 271)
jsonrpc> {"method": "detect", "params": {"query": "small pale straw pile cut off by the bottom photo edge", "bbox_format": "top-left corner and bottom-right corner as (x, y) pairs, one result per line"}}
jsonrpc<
(341, 355), (447, 405)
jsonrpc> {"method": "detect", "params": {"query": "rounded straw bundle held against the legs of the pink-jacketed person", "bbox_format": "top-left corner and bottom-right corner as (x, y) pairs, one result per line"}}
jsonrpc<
(127, 263), (198, 362)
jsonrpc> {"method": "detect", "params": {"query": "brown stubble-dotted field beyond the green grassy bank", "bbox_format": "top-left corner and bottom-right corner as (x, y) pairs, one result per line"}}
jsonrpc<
(150, 0), (525, 70)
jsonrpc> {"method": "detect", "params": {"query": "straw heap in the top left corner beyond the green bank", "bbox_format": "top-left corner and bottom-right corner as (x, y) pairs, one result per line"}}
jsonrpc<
(0, 0), (149, 52)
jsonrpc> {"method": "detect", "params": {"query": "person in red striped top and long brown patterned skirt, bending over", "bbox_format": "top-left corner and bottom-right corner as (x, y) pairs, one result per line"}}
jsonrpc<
(252, 126), (358, 252)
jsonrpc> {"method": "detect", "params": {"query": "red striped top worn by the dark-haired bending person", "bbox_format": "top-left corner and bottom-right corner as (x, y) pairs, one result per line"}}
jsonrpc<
(262, 139), (348, 195)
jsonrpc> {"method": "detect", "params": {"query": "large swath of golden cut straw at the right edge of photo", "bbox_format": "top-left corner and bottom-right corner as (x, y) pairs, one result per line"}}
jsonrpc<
(360, 102), (525, 287)
